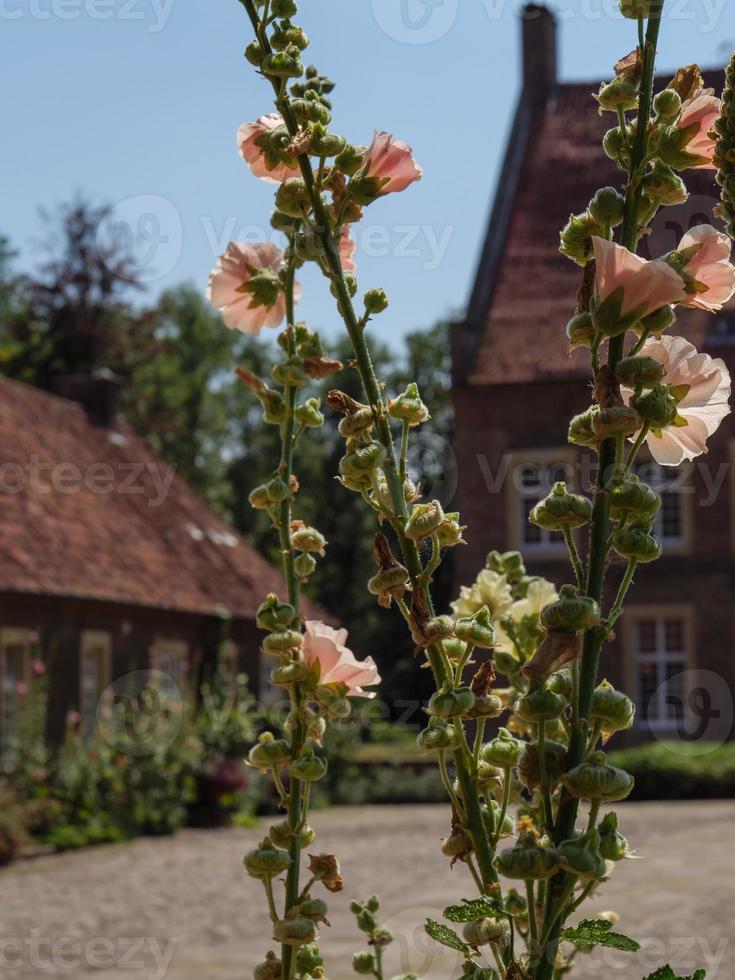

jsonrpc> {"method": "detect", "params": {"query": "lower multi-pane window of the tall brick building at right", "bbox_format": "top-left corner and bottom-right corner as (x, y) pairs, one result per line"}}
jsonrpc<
(633, 615), (689, 728)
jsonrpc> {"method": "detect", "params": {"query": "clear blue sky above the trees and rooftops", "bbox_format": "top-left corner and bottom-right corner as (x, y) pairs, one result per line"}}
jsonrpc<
(0, 0), (735, 341)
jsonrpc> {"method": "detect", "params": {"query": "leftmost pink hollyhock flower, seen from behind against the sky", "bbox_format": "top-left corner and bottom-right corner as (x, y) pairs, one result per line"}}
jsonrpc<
(207, 242), (300, 336)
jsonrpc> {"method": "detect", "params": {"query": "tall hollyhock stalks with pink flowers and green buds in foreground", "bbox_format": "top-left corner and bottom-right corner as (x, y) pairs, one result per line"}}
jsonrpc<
(220, 0), (735, 980)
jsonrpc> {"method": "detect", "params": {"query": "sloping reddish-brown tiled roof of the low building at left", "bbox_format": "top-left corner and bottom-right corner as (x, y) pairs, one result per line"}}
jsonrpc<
(0, 379), (315, 618)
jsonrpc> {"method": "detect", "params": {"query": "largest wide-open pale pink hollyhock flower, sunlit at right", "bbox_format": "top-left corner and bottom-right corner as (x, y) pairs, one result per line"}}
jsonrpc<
(640, 336), (730, 466)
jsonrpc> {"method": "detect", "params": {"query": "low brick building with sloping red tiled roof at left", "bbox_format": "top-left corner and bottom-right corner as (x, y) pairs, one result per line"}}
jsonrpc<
(0, 376), (315, 744)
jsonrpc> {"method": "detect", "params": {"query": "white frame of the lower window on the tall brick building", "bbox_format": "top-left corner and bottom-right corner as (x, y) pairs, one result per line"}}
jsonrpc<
(625, 606), (694, 732)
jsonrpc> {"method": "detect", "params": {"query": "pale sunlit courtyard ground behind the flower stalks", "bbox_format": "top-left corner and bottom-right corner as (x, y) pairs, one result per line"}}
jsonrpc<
(0, 802), (735, 980)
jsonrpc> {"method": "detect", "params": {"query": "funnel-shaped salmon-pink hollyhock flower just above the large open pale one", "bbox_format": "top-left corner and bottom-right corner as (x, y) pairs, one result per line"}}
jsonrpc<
(592, 236), (684, 318)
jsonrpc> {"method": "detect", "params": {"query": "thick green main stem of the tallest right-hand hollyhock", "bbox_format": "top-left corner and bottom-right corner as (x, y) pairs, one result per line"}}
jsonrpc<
(535, 7), (665, 980)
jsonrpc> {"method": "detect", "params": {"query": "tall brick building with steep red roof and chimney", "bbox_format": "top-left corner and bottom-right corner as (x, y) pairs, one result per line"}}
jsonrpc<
(452, 4), (735, 739)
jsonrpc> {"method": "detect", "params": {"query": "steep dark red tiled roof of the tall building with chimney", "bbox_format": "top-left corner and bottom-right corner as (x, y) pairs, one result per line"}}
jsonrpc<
(462, 71), (724, 384)
